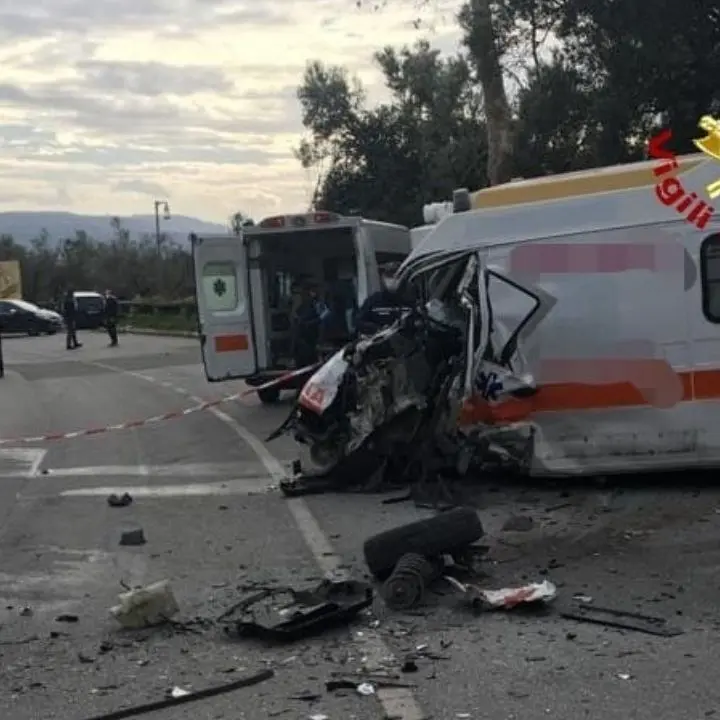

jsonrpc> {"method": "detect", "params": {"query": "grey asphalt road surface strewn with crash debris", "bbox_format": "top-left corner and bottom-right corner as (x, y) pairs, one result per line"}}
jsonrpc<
(0, 333), (720, 720)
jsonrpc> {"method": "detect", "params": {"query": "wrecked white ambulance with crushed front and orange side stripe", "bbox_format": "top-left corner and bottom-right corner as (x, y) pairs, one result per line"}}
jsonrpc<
(262, 156), (720, 480)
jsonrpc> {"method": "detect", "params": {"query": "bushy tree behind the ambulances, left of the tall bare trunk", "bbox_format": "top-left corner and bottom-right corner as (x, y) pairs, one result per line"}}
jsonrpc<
(297, 42), (486, 225)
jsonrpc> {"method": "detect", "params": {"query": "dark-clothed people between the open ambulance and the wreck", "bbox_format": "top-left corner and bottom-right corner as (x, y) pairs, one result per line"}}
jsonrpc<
(292, 268), (411, 368)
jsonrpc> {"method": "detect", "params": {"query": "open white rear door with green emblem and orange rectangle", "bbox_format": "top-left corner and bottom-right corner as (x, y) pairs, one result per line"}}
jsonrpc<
(190, 235), (257, 382)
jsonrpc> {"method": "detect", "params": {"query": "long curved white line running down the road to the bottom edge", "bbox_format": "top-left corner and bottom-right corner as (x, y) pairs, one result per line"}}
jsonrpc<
(93, 363), (428, 720)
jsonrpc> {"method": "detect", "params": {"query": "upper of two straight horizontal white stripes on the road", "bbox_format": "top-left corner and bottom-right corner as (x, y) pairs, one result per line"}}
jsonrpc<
(39, 463), (261, 478)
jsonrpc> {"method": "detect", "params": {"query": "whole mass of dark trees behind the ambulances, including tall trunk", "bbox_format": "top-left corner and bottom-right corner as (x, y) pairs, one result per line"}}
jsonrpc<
(298, 0), (720, 224)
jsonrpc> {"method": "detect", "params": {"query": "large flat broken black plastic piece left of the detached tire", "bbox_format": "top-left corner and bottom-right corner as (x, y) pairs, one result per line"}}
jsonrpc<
(218, 580), (373, 642)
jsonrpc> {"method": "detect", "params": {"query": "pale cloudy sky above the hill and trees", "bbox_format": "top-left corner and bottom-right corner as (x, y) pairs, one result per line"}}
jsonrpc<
(0, 0), (459, 223)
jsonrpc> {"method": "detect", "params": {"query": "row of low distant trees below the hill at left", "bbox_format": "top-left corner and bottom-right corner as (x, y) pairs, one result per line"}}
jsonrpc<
(0, 218), (195, 302)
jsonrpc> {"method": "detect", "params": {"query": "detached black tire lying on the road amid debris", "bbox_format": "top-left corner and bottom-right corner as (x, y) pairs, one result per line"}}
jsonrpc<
(363, 507), (485, 580)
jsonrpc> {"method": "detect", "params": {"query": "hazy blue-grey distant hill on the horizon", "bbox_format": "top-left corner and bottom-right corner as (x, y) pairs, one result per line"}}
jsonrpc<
(0, 212), (228, 245)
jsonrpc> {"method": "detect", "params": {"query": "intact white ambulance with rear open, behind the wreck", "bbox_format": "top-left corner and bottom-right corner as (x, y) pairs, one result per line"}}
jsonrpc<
(190, 212), (410, 403)
